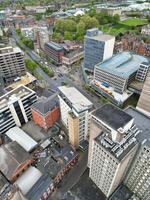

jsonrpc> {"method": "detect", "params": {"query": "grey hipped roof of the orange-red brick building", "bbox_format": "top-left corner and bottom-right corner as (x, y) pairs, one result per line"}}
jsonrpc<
(32, 94), (59, 115)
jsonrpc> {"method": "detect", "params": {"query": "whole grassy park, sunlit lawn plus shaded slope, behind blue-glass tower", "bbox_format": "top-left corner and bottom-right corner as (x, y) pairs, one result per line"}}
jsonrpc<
(100, 18), (148, 36)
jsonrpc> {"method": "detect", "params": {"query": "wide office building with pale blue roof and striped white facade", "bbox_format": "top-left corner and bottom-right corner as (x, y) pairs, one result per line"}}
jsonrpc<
(94, 52), (149, 94)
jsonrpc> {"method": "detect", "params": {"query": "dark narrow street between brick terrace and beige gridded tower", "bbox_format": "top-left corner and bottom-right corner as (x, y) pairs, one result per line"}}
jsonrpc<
(49, 151), (88, 200)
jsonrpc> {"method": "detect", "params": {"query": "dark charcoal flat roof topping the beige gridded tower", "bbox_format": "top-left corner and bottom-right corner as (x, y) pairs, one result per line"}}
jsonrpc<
(92, 104), (132, 130)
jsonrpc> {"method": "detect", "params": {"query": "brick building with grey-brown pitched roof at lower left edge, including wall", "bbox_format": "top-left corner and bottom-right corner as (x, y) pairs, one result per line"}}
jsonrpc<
(0, 141), (33, 182)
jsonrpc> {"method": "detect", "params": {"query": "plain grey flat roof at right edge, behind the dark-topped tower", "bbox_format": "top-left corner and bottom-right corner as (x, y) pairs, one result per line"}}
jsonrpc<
(125, 107), (150, 142)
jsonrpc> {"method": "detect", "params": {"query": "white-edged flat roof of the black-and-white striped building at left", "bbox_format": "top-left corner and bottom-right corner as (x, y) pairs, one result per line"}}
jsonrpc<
(0, 85), (35, 109)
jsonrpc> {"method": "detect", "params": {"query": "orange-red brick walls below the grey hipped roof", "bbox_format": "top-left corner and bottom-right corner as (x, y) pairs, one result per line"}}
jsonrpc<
(32, 107), (60, 130)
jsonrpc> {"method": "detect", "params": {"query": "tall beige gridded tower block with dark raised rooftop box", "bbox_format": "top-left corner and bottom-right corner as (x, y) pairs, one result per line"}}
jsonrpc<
(88, 104), (141, 197)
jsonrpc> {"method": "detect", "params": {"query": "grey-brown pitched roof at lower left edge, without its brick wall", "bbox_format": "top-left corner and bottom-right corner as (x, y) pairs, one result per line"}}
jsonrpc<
(0, 141), (31, 179)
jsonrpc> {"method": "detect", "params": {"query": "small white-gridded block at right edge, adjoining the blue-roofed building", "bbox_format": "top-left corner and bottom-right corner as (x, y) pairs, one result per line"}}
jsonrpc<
(135, 62), (150, 82)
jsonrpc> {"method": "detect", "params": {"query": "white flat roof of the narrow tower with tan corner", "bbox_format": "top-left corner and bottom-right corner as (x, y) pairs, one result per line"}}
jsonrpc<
(59, 86), (93, 112)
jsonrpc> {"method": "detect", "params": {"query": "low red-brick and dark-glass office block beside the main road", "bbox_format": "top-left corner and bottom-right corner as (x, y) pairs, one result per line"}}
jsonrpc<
(44, 42), (64, 65)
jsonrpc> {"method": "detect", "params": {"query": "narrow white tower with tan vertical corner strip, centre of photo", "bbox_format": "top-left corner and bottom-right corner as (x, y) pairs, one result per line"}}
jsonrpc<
(58, 86), (93, 147)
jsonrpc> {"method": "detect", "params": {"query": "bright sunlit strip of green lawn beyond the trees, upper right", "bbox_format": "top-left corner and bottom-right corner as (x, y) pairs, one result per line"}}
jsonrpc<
(120, 18), (148, 26)
